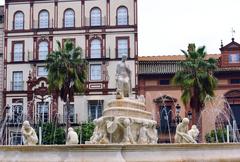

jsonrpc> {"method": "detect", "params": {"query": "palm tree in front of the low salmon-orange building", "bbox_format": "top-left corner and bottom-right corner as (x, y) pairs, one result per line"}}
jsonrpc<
(172, 44), (217, 123)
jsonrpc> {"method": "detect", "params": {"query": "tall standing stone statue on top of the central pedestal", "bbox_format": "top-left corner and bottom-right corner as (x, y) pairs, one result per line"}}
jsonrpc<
(116, 55), (132, 98)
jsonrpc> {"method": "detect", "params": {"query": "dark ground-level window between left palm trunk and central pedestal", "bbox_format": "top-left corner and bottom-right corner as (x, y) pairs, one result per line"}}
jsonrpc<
(88, 100), (103, 121)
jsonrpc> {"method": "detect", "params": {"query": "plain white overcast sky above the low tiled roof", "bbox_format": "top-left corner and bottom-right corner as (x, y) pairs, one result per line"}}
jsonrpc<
(0, 0), (240, 56)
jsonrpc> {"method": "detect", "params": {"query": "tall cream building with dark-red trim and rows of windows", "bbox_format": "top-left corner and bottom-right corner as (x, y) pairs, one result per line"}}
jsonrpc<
(4, 0), (138, 144)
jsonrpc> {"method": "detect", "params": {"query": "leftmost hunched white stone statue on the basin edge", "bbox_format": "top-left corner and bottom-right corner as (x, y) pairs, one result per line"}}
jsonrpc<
(21, 120), (38, 145)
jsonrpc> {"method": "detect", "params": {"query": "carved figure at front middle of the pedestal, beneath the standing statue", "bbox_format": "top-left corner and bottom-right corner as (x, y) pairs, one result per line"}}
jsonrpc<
(118, 118), (136, 144)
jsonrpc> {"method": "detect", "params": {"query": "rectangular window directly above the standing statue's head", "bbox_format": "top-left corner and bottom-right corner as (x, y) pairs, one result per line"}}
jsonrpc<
(117, 38), (129, 58)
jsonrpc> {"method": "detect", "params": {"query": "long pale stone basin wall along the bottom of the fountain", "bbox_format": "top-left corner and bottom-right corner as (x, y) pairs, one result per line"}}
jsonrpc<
(0, 144), (240, 162)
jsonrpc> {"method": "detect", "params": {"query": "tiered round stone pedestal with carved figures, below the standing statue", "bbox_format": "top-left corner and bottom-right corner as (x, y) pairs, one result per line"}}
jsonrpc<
(87, 98), (158, 144)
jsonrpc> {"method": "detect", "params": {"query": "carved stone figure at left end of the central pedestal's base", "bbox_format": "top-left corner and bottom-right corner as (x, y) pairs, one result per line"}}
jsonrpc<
(90, 118), (109, 144)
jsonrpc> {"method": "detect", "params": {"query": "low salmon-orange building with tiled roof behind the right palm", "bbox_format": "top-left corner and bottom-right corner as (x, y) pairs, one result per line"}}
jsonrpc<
(138, 39), (240, 142)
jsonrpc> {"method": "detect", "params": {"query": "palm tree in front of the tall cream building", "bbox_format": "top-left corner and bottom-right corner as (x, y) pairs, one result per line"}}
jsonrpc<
(46, 40), (87, 132)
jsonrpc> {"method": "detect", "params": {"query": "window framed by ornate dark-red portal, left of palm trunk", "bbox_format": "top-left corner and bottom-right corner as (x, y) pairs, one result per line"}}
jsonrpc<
(37, 102), (49, 123)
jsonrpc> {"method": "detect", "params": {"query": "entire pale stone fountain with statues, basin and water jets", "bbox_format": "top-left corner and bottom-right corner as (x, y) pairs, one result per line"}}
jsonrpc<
(0, 57), (240, 162)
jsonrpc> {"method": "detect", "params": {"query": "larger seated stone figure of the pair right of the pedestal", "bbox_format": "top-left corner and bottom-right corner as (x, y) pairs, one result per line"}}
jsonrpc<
(174, 118), (197, 143)
